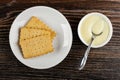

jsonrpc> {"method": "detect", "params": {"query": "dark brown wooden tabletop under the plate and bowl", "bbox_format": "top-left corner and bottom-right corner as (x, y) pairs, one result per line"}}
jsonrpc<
(0, 0), (120, 80)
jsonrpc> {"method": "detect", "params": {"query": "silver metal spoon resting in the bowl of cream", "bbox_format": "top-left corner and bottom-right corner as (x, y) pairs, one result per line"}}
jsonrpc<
(79, 31), (103, 70)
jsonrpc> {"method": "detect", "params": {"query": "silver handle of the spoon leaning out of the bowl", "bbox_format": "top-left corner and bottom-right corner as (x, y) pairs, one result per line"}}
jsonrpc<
(79, 38), (94, 70)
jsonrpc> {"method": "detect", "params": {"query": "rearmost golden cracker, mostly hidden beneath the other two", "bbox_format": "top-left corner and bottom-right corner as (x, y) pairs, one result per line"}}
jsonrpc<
(25, 16), (56, 38)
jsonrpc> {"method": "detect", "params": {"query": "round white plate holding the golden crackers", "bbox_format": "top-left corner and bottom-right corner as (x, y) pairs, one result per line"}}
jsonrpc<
(9, 6), (72, 69)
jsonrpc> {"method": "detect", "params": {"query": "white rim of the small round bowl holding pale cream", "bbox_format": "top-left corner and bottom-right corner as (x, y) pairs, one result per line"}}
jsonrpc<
(77, 12), (113, 48)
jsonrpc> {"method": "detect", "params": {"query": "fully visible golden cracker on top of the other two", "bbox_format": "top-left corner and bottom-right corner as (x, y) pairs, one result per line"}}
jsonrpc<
(20, 35), (53, 58)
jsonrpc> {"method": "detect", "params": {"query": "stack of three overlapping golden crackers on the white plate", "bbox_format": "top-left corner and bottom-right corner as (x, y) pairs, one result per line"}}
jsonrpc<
(19, 16), (56, 58)
